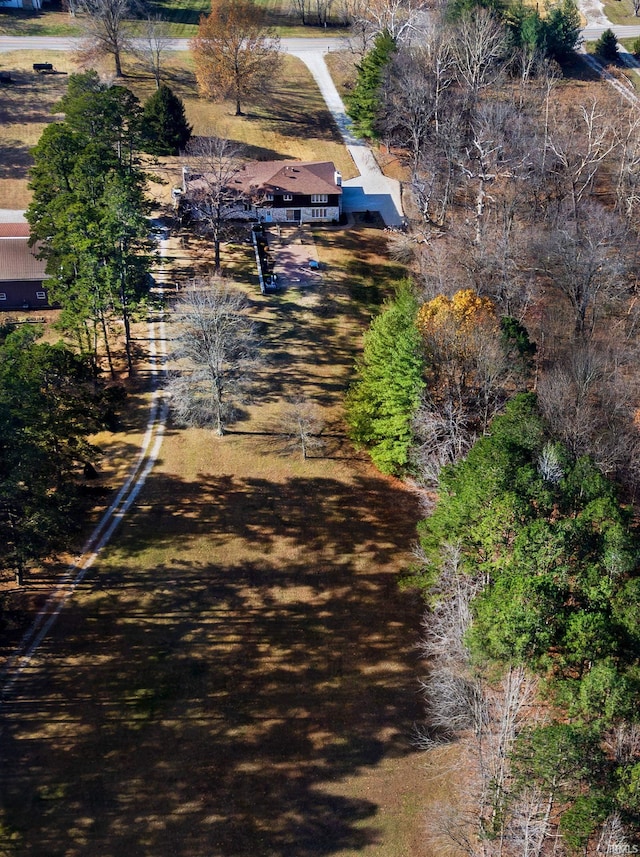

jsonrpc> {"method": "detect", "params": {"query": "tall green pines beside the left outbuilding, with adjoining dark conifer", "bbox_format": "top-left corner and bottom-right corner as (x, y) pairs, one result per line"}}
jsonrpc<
(26, 71), (190, 374)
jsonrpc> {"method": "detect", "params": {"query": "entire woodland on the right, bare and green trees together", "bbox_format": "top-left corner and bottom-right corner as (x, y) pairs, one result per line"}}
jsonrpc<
(346, 4), (640, 857)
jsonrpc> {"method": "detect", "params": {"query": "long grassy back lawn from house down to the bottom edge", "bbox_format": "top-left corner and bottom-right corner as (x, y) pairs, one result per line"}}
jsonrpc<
(0, 227), (448, 857)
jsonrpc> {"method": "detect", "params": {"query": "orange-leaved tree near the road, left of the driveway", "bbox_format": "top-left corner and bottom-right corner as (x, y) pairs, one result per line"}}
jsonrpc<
(191, 0), (280, 116)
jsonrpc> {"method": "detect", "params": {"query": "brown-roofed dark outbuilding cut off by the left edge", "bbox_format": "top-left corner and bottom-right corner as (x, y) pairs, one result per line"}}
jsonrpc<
(0, 222), (49, 312)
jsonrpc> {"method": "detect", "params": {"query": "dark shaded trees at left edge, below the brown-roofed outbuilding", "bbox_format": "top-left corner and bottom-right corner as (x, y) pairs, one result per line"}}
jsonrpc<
(0, 325), (121, 583)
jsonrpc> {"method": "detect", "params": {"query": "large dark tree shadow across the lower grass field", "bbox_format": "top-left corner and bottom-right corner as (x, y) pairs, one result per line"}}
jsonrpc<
(0, 473), (420, 857)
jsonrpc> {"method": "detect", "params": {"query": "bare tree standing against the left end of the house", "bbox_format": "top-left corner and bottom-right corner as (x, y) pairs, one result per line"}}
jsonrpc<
(186, 136), (248, 272)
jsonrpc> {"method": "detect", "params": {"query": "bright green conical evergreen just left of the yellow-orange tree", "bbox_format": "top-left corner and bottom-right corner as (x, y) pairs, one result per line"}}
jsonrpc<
(346, 282), (424, 473)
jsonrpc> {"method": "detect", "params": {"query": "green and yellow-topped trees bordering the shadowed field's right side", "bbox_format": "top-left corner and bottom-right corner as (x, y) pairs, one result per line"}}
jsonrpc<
(347, 290), (640, 857)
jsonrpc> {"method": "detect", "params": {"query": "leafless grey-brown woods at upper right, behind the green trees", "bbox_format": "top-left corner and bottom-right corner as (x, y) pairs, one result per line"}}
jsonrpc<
(344, 4), (640, 496)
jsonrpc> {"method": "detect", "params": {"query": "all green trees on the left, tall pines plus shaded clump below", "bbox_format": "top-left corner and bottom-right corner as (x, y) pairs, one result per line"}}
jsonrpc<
(0, 71), (189, 583)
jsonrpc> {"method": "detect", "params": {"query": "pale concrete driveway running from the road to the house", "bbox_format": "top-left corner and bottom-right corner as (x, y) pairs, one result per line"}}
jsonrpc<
(290, 49), (404, 226)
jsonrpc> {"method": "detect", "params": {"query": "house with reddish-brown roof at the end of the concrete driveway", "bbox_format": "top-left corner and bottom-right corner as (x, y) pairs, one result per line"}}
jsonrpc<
(181, 161), (342, 223)
